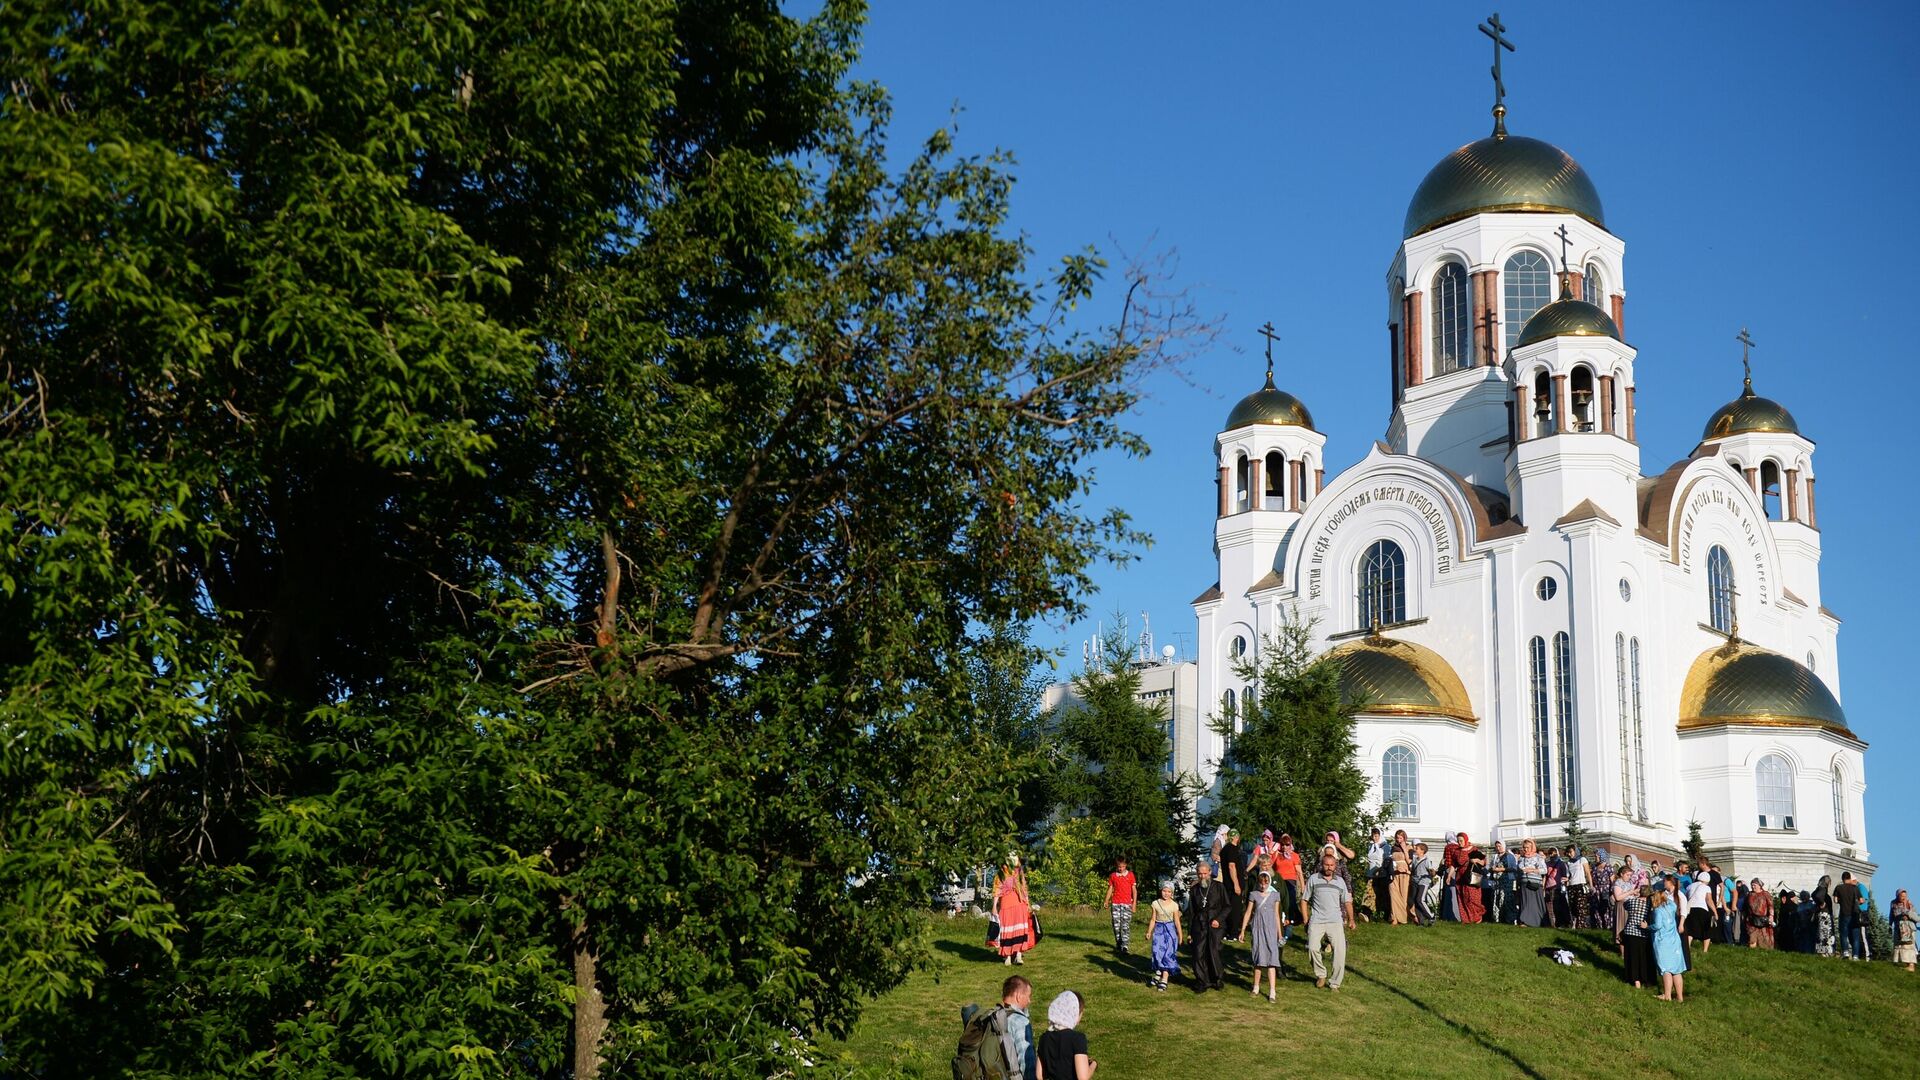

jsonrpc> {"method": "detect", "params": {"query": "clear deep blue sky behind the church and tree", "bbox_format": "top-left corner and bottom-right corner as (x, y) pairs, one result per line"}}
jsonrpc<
(860, 0), (1920, 891)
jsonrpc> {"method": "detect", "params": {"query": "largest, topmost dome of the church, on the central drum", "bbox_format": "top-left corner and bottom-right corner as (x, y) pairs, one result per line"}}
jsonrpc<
(1405, 135), (1607, 236)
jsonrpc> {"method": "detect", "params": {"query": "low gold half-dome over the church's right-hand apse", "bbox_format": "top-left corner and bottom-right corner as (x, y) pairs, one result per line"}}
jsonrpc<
(1680, 640), (1853, 734)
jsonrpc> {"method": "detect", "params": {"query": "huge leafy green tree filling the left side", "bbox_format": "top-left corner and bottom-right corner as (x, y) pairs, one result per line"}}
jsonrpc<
(0, 0), (1190, 1076)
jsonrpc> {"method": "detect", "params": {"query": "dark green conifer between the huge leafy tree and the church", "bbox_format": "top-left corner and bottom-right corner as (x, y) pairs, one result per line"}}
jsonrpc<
(1054, 621), (1194, 878)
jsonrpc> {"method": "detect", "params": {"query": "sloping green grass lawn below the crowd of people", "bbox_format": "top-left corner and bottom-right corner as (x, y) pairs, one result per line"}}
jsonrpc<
(841, 909), (1920, 1080)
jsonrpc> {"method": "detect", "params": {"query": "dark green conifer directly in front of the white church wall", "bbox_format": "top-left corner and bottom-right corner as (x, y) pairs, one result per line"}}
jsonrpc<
(1206, 617), (1384, 847)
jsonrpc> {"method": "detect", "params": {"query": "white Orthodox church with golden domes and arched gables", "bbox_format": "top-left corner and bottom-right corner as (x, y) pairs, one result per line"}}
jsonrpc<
(1194, 110), (1872, 888)
